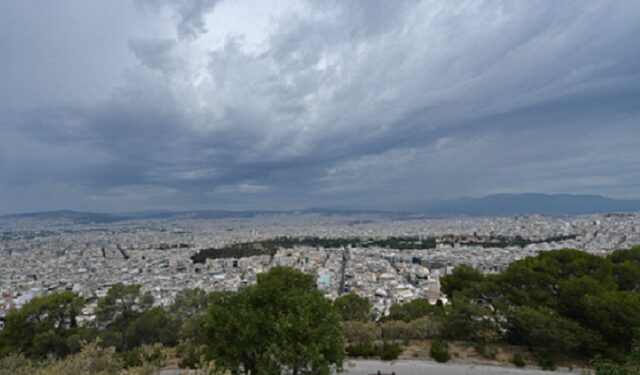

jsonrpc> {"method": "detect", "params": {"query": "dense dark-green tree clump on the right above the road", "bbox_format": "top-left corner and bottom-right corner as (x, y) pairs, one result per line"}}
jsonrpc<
(441, 247), (640, 362)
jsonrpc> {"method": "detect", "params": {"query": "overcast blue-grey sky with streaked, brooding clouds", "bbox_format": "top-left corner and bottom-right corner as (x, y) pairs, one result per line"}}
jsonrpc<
(0, 0), (640, 214)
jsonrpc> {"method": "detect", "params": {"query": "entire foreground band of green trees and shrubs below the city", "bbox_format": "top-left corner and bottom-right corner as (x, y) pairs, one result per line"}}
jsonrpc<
(0, 246), (640, 374)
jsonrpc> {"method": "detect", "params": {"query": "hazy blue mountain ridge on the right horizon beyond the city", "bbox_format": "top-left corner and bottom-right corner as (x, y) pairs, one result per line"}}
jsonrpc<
(420, 193), (640, 216)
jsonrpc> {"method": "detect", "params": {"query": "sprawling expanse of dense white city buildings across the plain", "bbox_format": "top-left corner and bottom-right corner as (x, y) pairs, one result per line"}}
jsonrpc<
(0, 214), (640, 328)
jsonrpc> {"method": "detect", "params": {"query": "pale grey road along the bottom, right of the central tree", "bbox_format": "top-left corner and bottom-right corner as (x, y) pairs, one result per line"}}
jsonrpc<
(344, 360), (582, 375)
